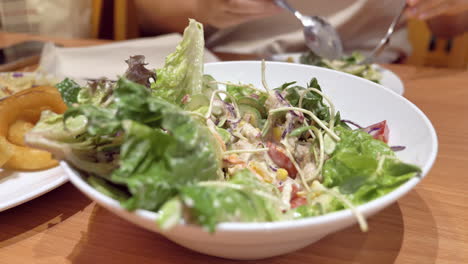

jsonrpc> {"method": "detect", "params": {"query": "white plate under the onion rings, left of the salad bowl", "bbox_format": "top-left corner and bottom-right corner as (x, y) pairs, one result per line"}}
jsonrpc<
(0, 72), (68, 212)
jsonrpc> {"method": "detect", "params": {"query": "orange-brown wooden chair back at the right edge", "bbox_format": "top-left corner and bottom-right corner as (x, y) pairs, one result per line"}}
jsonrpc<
(408, 19), (468, 69)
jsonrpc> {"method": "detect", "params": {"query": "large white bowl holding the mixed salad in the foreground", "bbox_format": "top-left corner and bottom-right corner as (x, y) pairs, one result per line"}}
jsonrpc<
(61, 61), (437, 259)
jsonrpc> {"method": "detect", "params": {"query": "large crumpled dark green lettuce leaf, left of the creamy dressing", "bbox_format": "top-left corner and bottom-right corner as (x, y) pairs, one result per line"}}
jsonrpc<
(111, 112), (220, 211)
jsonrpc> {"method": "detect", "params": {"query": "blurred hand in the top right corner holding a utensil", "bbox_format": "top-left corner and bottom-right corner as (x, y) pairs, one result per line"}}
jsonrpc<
(406, 0), (468, 20)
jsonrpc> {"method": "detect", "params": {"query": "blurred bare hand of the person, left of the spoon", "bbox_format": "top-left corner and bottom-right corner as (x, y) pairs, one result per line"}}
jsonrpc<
(195, 0), (281, 28)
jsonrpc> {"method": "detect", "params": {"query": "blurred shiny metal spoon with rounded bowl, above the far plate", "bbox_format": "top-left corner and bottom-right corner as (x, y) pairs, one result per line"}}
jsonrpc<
(275, 0), (343, 59)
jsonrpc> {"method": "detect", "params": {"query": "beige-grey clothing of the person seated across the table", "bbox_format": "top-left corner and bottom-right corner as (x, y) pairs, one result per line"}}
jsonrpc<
(207, 0), (408, 60)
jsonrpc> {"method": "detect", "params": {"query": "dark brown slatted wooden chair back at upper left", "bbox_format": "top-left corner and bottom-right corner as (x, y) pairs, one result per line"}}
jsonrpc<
(91, 0), (139, 40)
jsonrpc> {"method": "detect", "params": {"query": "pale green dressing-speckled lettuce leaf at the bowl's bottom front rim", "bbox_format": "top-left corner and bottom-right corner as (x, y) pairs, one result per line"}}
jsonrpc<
(168, 169), (284, 232)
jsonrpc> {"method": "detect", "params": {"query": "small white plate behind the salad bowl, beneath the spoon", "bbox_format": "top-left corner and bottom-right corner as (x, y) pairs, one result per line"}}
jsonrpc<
(271, 53), (405, 95)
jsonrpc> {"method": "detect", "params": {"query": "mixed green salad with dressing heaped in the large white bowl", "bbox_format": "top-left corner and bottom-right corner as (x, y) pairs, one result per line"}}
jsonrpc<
(26, 20), (420, 231)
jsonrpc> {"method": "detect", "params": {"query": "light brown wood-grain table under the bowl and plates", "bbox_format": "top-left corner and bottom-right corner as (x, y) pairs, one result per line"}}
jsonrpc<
(0, 33), (468, 264)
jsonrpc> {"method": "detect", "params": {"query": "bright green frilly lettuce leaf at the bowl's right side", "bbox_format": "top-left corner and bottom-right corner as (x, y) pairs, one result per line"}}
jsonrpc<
(323, 126), (421, 204)
